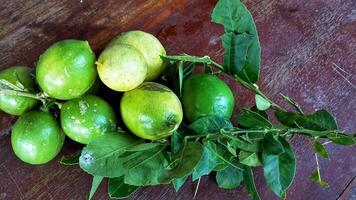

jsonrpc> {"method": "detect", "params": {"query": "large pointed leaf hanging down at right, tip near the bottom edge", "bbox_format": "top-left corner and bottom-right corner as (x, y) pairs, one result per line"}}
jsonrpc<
(262, 137), (296, 197)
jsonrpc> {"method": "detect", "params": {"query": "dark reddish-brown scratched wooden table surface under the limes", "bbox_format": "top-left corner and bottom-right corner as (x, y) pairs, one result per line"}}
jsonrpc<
(0, 0), (356, 200)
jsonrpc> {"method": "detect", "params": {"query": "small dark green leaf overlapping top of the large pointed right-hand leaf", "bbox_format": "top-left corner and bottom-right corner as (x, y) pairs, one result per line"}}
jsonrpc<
(263, 133), (284, 155)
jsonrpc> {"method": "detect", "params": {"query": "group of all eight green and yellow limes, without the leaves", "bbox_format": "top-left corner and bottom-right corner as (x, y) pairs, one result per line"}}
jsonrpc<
(0, 31), (234, 164)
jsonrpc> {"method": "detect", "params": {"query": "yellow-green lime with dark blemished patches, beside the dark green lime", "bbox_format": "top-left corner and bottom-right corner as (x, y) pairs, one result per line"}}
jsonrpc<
(120, 82), (183, 140)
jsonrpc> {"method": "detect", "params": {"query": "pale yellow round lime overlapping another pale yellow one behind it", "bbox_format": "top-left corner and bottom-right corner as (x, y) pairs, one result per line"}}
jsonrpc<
(96, 44), (147, 92)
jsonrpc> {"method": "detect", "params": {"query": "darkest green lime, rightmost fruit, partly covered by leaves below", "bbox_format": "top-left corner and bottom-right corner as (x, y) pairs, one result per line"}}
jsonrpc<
(182, 73), (235, 122)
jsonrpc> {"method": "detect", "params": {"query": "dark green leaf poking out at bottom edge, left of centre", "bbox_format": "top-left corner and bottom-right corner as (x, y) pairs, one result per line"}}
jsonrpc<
(108, 176), (140, 199)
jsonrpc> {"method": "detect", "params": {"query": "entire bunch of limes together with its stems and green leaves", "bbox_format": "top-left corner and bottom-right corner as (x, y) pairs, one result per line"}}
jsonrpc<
(0, 0), (356, 200)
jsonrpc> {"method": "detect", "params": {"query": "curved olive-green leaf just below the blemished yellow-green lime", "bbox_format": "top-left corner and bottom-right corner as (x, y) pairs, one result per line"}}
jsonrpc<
(163, 142), (203, 180)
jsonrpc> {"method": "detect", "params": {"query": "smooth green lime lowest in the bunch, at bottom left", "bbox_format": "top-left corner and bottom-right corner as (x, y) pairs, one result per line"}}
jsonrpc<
(11, 111), (65, 165)
